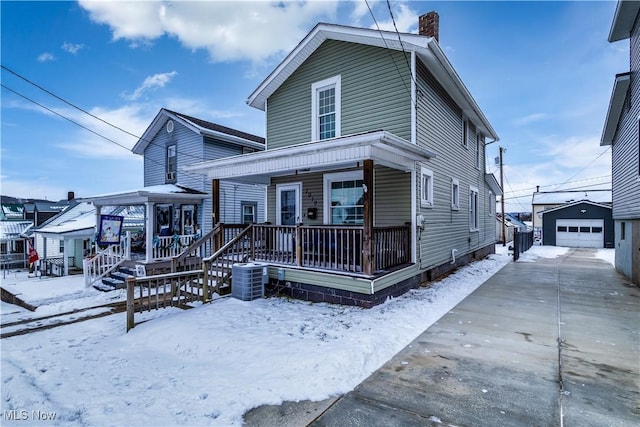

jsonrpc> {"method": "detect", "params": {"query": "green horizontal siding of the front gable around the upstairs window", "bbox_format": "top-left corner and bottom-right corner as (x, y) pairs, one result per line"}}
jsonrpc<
(267, 40), (411, 149)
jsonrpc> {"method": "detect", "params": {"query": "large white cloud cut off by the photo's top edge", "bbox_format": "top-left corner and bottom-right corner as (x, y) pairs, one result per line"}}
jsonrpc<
(80, 0), (338, 62)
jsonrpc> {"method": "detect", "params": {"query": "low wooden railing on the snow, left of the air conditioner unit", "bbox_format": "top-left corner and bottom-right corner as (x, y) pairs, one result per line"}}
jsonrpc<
(127, 270), (208, 332)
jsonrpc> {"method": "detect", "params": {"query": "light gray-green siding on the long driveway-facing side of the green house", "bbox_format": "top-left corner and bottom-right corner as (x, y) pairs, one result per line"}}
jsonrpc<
(416, 61), (496, 268)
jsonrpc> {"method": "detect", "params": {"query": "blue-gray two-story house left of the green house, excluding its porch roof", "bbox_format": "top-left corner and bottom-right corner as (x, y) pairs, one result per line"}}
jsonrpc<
(132, 108), (265, 234)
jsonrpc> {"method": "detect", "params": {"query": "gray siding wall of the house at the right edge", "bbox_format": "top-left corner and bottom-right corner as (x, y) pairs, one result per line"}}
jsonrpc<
(611, 14), (640, 219)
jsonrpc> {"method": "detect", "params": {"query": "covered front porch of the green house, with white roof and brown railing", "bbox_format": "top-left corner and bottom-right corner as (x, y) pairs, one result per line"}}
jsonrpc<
(187, 131), (434, 278)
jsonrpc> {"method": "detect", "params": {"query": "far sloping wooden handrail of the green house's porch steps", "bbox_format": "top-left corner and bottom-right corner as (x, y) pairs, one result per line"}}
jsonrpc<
(171, 223), (247, 272)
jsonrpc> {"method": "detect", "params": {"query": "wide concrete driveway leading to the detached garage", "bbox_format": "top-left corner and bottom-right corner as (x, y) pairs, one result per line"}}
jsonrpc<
(245, 249), (640, 427)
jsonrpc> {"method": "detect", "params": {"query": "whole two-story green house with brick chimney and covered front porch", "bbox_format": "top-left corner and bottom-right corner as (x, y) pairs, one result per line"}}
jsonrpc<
(186, 13), (501, 306)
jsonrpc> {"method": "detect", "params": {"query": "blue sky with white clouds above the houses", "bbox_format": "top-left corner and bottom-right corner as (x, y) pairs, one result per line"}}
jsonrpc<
(0, 0), (629, 211)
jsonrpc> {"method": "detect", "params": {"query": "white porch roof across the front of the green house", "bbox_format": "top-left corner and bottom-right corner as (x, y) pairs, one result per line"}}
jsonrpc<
(185, 131), (436, 184)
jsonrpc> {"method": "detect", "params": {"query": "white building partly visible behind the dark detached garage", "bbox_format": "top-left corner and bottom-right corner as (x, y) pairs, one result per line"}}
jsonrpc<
(531, 190), (611, 235)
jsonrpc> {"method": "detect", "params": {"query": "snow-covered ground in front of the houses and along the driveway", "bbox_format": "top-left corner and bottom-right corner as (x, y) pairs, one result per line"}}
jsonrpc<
(0, 245), (613, 426)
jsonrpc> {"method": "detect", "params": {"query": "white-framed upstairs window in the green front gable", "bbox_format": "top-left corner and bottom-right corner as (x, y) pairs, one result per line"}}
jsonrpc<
(311, 76), (342, 141)
